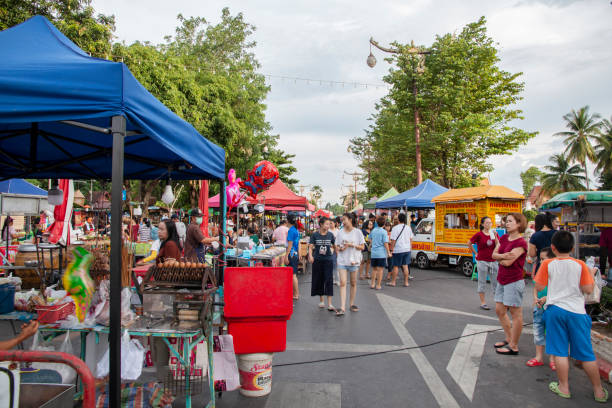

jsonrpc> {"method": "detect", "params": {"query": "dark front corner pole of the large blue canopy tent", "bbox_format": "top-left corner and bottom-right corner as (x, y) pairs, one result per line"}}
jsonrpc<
(109, 116), (126, 407)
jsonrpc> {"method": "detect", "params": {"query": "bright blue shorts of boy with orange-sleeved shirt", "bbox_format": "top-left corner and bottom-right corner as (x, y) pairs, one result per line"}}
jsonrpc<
(544, 305), (595, 361)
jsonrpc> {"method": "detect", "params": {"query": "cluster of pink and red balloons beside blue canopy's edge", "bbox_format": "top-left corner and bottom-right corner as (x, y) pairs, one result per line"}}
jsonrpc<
(225, 160), (278, 209)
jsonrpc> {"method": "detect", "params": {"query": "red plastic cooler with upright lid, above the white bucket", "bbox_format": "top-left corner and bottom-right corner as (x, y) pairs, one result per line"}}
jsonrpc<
(223, 267), (293, 354)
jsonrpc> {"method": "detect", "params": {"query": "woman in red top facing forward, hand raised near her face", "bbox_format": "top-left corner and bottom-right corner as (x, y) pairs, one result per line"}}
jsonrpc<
(468, 217), (498, 310)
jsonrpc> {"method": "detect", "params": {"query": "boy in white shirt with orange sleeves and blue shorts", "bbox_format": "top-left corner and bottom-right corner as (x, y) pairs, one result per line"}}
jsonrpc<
(535, 231), (608, 402)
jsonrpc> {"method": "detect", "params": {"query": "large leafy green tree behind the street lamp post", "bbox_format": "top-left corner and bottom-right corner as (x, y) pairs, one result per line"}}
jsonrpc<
(350, 18), (535, 194)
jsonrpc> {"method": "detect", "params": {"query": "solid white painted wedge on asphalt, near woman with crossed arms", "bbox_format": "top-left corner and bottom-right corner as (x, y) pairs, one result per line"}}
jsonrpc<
(446, 324), (499, 402)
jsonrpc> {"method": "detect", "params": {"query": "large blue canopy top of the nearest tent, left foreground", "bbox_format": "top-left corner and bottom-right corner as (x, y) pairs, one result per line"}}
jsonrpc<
(0, 16), (225, 179)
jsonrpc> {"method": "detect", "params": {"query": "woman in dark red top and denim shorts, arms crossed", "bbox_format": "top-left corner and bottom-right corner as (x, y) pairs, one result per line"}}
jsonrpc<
(493, 213), (527, 356)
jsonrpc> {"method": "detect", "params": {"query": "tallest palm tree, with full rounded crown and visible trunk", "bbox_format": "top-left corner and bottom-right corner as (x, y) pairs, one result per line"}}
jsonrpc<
(555, 105), (601, 190)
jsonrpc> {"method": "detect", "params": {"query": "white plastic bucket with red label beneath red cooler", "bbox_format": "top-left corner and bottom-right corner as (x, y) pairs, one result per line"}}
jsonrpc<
(237, 353), (274, 397)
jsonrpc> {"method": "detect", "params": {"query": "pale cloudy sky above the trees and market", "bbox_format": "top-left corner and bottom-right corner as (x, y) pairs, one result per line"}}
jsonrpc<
(93, 0), (612, 203)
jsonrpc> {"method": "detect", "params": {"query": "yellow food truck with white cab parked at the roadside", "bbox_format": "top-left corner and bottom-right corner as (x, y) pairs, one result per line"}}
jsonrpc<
(411, 185), (525, 276)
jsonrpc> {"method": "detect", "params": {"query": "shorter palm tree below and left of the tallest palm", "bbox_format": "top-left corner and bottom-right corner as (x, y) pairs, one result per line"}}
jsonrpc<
(542, 153), (586, 196)
